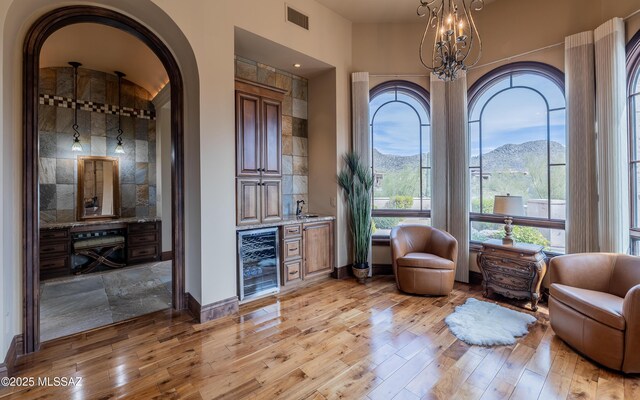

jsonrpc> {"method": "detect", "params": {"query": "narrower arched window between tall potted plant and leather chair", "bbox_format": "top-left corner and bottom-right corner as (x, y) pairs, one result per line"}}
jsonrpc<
(369, 81), (431, 236)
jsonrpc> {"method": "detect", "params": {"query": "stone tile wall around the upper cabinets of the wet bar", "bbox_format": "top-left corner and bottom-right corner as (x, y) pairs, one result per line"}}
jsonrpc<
(235, 56), (309, 215)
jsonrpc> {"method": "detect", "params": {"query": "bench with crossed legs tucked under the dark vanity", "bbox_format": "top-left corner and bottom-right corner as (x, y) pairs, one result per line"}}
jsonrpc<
(73, 235), (126, 275)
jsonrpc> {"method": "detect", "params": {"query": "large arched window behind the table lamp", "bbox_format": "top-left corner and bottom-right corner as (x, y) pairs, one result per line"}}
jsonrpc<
(469, 62), (566, 253)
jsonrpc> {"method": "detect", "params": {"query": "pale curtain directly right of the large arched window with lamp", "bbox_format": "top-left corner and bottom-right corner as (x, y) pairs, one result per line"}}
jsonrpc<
(564, 31), (598, 253)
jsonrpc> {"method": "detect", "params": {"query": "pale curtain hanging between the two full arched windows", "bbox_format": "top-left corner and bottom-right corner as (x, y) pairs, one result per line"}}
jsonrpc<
(431, 72), (469, 282)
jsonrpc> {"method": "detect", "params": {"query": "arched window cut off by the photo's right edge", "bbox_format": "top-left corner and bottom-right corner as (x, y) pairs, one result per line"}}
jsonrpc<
(627, 31), (640, 255)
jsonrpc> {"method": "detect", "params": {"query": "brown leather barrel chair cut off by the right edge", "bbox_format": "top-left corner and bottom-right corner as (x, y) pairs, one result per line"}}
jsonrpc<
(549, 253), (640, 373)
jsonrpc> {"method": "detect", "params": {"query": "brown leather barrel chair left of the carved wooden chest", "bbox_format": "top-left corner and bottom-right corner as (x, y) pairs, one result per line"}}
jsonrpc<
(391, 225), (458, 296)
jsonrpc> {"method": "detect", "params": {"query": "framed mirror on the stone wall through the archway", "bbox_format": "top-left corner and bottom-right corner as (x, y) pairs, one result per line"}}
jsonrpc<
(76, 156), (120, 221)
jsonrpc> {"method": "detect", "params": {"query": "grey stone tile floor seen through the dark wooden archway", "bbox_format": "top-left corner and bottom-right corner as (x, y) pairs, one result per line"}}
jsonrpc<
(40, 261), (171, 342)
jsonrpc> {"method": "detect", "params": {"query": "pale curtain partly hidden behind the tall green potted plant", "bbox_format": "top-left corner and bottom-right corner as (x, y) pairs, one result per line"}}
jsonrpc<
(351, 72), (371, 275)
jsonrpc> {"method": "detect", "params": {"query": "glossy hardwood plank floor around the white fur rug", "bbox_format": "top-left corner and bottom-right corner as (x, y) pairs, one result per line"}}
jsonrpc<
(0, 277), (640, 400)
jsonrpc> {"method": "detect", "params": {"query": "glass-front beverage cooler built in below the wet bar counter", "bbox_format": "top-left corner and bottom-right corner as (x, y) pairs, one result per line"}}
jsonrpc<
(238, 228), (280, 300)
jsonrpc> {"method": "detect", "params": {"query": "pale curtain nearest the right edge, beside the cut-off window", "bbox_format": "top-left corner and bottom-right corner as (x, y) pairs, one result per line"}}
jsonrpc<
(594, 18), (629, 253)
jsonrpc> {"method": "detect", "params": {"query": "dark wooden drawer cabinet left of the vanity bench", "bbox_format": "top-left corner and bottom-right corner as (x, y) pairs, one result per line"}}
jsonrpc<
(40, 228), (71, 280)
